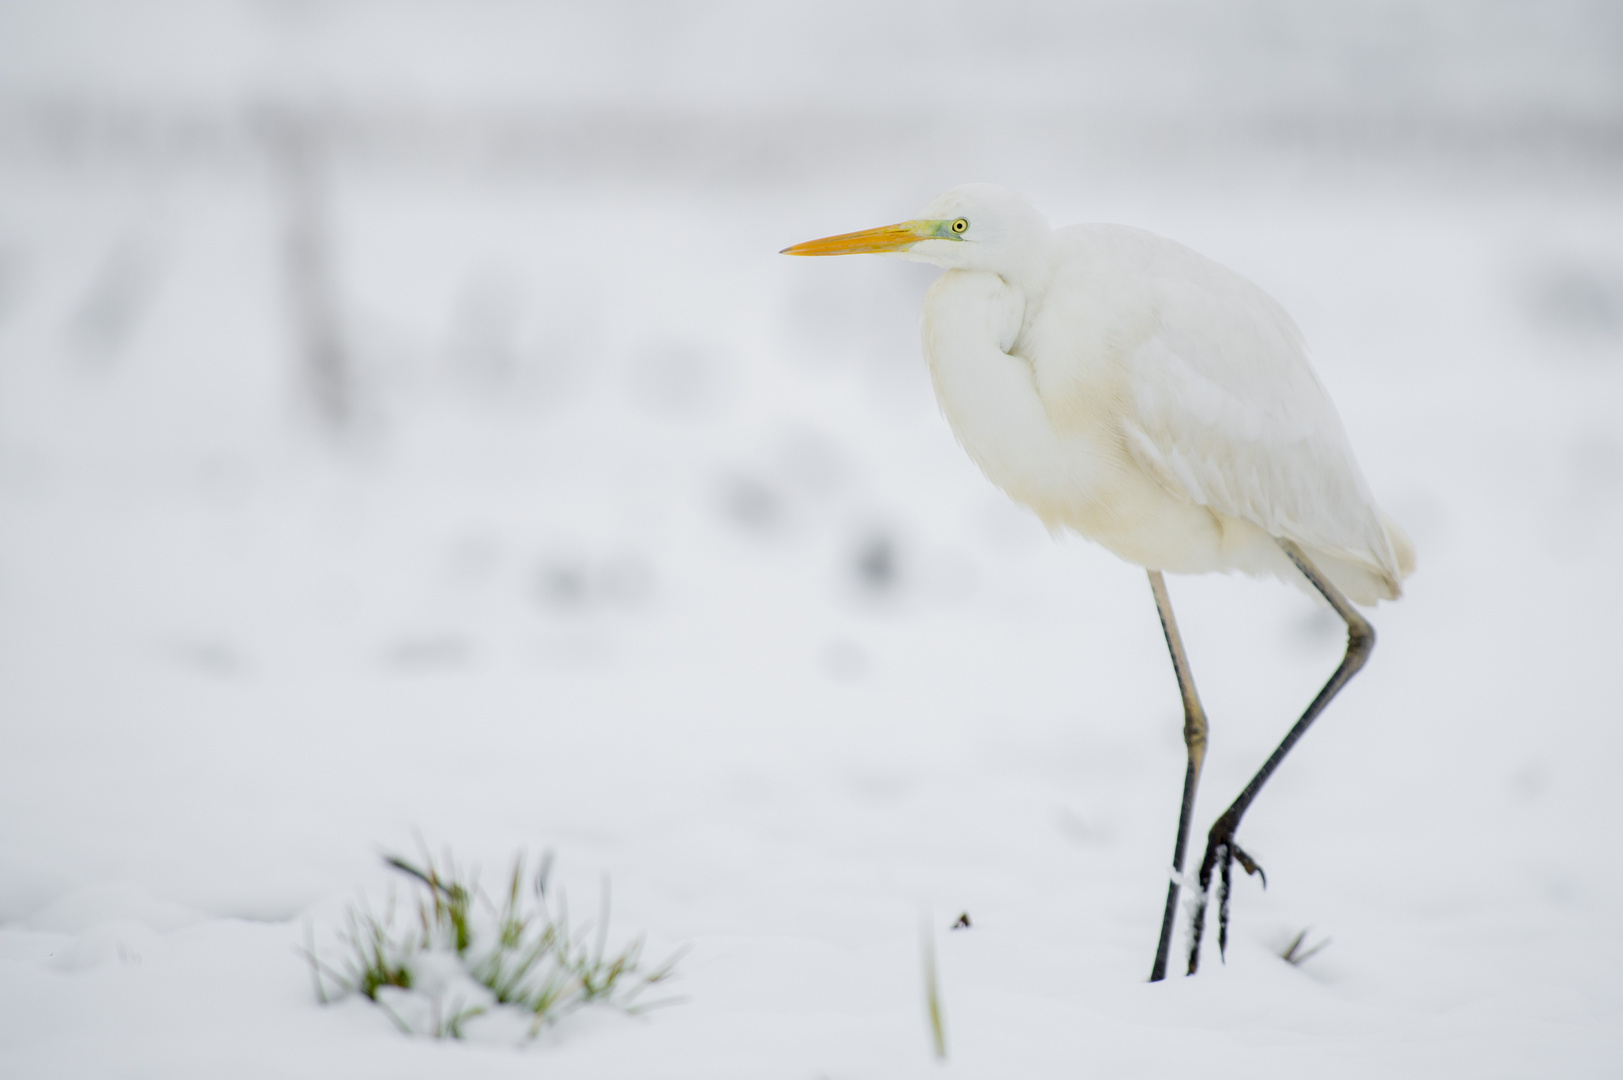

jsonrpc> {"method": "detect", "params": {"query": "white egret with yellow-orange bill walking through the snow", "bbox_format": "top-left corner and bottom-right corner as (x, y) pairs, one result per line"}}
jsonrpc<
(784, 184), (1414, 981)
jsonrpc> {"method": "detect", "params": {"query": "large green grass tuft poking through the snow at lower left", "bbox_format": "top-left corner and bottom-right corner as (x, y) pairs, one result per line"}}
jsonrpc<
(302, 848), (682, 1039)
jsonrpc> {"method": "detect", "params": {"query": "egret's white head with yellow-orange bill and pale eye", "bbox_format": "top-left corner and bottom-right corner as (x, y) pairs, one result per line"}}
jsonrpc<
(782, 184), (1053, 284)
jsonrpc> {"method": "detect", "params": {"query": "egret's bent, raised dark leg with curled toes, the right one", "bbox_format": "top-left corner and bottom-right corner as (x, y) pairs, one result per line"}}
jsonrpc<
(1190, 539), (1375, 974)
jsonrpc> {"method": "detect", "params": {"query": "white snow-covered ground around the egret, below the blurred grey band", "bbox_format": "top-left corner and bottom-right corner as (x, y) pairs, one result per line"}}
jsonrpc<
(0, 2), (1623, 1080)
